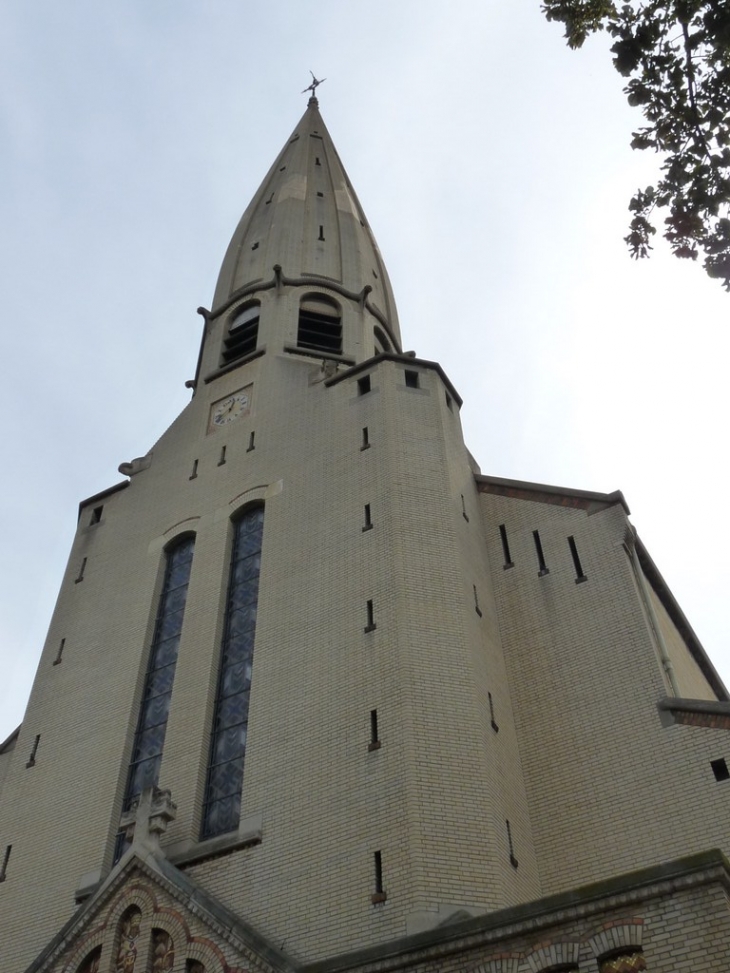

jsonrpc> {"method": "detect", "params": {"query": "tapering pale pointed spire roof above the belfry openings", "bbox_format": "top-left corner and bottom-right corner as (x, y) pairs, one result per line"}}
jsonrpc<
(212, 97), (400, 350)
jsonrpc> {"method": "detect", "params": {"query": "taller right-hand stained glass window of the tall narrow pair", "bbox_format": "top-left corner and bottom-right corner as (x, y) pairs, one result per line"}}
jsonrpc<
(202, 507), (264, 838)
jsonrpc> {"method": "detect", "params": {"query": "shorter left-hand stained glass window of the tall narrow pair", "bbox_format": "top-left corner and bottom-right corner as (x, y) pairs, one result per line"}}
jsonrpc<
(124, 537), (195, 810)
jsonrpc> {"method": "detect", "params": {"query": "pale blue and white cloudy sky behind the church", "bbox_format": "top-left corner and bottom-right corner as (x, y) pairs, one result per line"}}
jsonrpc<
(0, 0), (730, 741)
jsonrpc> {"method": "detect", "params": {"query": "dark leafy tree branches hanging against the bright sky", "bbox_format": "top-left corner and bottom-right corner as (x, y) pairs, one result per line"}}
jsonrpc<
(542, 0), (730, 291)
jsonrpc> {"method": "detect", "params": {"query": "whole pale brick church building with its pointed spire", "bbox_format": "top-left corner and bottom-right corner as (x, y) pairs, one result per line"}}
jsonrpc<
(0, 97), (730, 973)
